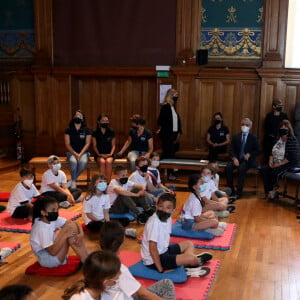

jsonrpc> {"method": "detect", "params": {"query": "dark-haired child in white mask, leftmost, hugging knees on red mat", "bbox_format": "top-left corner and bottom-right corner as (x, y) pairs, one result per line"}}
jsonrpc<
(7, 168), (40, 221)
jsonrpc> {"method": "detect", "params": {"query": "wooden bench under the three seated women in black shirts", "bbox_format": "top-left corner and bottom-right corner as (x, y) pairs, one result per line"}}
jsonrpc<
(29, 156), (129, 183)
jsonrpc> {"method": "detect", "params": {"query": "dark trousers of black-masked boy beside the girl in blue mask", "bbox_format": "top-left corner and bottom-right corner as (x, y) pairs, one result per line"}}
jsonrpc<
(109, 195), (150, 215)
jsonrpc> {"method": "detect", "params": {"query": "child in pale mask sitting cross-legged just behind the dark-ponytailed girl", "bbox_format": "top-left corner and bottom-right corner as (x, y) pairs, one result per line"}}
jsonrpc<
(200, 167), (235, 218)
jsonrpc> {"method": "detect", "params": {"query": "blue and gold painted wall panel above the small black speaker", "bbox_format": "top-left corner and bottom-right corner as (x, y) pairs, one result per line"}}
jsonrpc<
(200, 0), (263, 59)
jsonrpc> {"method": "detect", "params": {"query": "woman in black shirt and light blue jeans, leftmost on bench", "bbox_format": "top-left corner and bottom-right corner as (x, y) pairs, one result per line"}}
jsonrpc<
(65, 109), (92, 188)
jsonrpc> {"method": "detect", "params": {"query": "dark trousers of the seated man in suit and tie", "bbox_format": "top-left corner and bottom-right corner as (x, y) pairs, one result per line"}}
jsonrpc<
(225, 160), (251, 196)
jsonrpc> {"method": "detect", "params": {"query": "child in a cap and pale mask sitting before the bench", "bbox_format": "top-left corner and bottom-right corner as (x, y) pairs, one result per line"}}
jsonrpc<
(41, 155), (82, 208)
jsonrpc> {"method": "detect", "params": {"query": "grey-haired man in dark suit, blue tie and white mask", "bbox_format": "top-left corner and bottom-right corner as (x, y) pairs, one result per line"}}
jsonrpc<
(225, 118), (260, 199)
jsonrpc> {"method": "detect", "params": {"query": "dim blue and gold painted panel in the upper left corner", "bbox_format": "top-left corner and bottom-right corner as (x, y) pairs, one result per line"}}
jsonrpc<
(0, 0), (34, 59)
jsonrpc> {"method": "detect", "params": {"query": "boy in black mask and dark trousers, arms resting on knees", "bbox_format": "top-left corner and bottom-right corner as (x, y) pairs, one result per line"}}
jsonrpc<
(107, 166), (154, 224)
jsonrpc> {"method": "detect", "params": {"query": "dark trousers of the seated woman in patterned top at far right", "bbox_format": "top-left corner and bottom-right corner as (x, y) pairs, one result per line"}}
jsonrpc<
(260, 164), (288, 194)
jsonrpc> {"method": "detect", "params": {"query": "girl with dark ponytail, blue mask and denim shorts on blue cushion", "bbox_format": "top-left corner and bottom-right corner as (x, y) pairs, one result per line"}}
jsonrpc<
(181, 174), (227, 236)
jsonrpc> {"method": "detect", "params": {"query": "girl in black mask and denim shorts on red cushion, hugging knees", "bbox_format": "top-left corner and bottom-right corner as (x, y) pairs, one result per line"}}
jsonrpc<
(30, 196), (88, 268)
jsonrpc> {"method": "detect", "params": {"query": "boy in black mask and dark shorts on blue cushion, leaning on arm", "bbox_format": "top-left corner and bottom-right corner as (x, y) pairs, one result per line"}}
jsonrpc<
(141, 193), (212, 273)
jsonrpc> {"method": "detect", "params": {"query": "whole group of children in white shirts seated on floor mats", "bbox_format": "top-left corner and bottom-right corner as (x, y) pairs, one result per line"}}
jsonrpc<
(1, 153), (235, 300)
